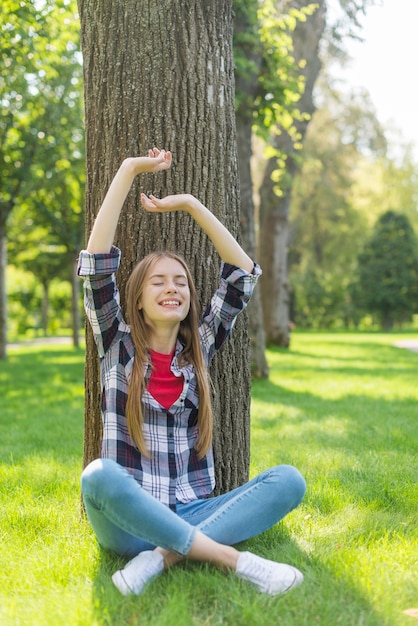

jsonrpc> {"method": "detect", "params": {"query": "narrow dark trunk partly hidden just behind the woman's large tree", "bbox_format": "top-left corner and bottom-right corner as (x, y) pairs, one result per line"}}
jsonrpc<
(234, 3), (269, 378)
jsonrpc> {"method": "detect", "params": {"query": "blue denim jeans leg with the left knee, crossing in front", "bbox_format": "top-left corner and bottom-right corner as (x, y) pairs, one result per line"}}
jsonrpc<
(81, 459), (196, 556)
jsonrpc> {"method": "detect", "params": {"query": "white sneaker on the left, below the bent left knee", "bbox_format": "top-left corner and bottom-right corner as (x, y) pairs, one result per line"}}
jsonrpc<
(112, 550), (164, 596)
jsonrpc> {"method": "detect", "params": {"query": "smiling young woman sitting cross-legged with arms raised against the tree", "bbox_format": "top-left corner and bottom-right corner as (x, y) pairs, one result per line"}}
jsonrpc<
(78, 148), (305, 595)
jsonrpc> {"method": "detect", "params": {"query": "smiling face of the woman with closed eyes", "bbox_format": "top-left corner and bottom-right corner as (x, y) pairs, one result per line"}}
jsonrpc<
(138, 257), (190, 327)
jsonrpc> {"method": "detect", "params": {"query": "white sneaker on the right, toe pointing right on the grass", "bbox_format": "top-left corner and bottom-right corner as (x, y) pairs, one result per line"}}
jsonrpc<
(236, 552), (303, 596)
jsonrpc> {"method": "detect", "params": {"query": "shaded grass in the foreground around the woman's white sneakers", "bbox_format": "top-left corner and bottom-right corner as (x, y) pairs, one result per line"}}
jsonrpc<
(89, 525), (390, 626)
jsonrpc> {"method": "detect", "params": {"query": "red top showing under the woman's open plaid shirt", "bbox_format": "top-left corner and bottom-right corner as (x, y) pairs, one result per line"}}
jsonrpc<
(147, 350), (184, 410)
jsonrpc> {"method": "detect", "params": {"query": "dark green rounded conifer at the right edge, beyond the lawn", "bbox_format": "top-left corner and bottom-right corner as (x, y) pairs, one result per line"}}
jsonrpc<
(357, 211), (418, 330)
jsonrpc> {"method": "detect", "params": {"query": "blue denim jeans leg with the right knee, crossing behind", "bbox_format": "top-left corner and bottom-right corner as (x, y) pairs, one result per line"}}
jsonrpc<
(178, 465), (306, 545)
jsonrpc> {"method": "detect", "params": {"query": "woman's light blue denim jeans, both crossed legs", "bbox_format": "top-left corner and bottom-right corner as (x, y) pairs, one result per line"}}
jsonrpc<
(81, 459), (306, 556)
